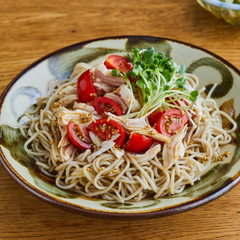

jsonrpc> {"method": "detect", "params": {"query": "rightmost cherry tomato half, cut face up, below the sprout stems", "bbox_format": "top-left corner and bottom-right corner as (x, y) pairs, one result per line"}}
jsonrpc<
(156, 109), (189, 137)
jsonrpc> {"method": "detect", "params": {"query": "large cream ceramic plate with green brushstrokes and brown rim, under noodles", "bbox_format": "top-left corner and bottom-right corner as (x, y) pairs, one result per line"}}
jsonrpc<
(0, 36), (240, 218)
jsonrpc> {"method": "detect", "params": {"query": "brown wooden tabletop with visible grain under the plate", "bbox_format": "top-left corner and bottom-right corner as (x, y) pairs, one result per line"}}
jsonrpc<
(0, 0), (240, 240)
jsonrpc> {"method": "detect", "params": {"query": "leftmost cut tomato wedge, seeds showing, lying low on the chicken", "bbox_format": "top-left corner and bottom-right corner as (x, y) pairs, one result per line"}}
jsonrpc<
(67, 121), (92, 150)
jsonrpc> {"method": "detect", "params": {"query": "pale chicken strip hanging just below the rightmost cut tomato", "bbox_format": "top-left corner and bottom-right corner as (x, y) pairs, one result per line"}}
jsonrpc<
(162, 125), (187, 169)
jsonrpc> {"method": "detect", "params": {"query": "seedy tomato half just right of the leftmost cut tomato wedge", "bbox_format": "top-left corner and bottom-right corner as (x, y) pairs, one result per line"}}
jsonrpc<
(88, 118), (125, 147)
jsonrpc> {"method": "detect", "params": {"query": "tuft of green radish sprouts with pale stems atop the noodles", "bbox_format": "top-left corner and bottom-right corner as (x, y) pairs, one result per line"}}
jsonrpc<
(112, 47), (198, 117)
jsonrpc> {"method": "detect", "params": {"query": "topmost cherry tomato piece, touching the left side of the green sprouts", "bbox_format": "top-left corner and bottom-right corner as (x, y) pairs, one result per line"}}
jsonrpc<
(104, 55), (133, 73)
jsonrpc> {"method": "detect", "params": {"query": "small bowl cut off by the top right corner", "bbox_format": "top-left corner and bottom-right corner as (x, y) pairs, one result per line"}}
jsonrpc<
(197, 0), (240, 27)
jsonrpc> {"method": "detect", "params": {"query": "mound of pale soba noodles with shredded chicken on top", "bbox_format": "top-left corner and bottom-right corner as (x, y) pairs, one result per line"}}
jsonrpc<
(20, 49), (236, 202)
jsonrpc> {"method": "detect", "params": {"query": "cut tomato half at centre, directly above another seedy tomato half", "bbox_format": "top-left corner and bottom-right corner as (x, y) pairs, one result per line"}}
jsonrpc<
(92, 97), (123, 117)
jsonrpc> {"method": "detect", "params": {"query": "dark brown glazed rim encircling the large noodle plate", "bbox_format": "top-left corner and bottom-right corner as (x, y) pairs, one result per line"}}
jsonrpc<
(0, 35), (240, 219)
